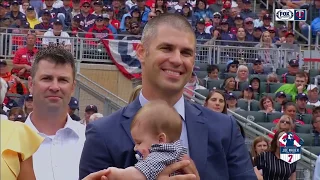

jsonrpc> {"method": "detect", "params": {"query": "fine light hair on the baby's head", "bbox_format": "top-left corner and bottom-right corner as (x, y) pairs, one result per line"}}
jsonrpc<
(130, 100), (182, 143)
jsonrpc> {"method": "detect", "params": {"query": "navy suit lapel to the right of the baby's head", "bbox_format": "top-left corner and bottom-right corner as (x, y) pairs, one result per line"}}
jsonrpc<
(185, 101), (208, 174)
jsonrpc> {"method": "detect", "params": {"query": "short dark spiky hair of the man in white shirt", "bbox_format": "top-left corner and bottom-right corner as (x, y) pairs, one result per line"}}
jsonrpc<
(31, 45), (76, 79)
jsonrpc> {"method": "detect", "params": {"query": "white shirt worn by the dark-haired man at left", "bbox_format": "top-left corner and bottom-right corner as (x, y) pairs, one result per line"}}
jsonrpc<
(25, 115), (85, 180)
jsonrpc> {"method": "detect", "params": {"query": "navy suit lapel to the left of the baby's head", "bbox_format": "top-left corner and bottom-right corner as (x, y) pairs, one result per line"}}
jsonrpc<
(121, 98), (141, 144)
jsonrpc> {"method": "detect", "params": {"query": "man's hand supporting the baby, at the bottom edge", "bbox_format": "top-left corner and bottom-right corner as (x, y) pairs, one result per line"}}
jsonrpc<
(157, 160), (200, 180)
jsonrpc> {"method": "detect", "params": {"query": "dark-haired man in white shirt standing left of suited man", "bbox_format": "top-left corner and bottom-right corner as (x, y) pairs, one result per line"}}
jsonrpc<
(25, 46), (85, 180)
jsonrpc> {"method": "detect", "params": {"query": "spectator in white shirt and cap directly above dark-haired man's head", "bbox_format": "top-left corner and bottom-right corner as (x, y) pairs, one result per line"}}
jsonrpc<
(42, 19), (71, 50)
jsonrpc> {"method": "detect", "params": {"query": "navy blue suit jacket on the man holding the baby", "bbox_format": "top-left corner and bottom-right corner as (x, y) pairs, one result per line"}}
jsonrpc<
(79, 98), (257, 180)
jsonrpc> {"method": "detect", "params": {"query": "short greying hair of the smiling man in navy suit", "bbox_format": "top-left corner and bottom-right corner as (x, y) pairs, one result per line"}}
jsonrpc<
(141, 13), (196, 47)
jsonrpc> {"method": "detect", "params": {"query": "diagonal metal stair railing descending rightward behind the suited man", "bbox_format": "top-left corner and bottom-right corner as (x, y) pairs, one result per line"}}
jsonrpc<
(184, 87), (317, 179)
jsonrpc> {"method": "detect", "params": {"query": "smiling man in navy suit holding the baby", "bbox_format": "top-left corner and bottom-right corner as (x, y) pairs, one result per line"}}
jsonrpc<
(79, 14), (257, 180)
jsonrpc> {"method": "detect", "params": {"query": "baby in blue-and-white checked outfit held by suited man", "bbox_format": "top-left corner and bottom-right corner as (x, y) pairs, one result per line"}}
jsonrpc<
(107, 100), (187, 180)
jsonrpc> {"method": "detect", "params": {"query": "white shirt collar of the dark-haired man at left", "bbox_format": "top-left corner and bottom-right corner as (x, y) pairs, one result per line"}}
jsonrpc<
(25, 112), (81, 138)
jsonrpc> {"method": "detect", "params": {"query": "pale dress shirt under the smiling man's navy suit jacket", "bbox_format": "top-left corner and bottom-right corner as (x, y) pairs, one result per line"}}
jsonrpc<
(139, 92), (189, 153)
